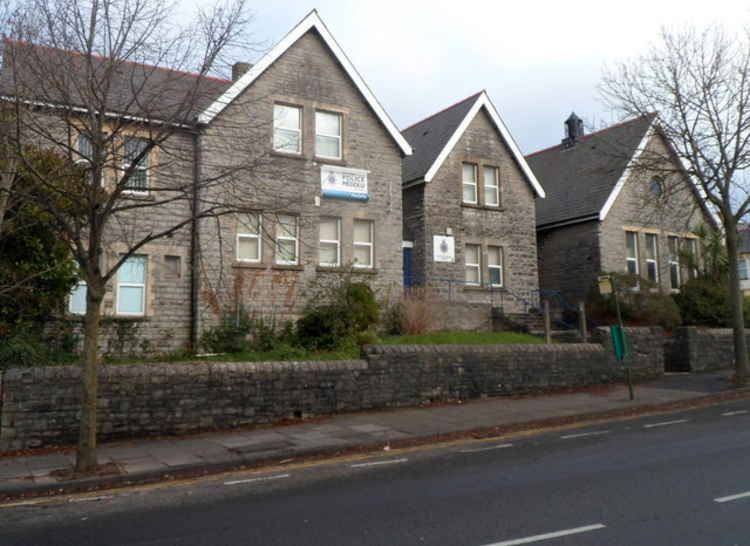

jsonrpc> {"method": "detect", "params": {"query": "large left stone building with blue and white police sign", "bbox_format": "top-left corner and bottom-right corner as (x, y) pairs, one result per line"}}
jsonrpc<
(0, 11), (411, 352)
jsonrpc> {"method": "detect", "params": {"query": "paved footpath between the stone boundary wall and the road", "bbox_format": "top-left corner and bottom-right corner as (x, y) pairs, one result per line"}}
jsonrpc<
(0, 372), (750, 501)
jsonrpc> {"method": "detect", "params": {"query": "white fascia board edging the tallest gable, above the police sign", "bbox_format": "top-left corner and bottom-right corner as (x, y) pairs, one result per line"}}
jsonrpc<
(198, 10), (412, 155)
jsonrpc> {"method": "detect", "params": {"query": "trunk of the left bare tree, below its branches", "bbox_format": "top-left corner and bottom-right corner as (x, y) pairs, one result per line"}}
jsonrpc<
(76, 285), (103, 472)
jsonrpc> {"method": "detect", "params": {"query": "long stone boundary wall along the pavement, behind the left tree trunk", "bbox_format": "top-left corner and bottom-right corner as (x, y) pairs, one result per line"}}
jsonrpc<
(0, 332), (661, 451)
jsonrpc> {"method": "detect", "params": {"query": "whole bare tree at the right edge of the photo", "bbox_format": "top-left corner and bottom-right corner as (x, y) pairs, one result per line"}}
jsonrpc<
(601, 26), (750, 385)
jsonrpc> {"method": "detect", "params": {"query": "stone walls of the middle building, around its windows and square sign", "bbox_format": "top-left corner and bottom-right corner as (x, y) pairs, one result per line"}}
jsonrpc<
(404, 110), (539, 312)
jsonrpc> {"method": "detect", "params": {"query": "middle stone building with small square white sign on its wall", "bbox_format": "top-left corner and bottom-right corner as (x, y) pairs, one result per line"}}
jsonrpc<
(403, 91), (544, 313)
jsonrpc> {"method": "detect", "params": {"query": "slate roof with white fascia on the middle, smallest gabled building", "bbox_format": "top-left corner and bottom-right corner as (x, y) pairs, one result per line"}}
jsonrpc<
(403, 91), (545, 197)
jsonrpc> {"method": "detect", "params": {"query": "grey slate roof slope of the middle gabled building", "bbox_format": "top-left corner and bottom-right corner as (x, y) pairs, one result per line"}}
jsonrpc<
(401, 91), (482, 184)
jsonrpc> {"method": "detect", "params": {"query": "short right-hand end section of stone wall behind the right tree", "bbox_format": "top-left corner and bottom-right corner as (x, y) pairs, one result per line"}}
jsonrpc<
(667, 326), (750, 372)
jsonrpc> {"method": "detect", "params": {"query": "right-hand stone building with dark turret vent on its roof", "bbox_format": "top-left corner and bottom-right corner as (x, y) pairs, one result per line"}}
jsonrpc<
(526, 114), (715, 299)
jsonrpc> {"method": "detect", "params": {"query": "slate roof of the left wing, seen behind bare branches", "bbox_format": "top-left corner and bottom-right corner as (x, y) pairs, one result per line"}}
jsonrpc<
(0, 40), (232, 122)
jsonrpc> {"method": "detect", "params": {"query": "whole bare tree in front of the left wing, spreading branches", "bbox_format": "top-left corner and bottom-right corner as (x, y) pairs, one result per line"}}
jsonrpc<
(0, 0), (296, 472)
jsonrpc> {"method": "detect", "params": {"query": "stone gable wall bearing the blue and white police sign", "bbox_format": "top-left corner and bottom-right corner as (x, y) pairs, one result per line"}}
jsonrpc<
(195, 31), (403, 330)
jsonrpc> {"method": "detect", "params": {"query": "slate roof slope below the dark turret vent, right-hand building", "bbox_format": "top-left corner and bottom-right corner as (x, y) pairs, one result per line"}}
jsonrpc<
(526, 114), (655, 227)
